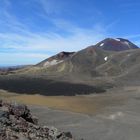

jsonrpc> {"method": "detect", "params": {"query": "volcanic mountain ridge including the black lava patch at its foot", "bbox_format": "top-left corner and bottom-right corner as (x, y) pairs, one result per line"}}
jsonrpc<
(0, 38), (140, 96)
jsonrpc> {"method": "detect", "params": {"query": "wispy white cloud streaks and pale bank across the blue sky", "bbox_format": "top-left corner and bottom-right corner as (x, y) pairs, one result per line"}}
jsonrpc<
(0, 0), (110, 64)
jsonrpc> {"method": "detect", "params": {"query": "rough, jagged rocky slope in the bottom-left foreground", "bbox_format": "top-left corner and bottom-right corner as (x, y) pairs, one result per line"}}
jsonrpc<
(0, 101), (73, 140)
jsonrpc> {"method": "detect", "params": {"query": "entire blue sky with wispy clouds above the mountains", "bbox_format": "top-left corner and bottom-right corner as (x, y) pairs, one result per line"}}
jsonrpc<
(0, 0), (140, 65)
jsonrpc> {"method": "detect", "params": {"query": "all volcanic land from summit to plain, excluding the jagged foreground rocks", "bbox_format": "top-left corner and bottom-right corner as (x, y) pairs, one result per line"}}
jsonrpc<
(0, 38), (140, 140)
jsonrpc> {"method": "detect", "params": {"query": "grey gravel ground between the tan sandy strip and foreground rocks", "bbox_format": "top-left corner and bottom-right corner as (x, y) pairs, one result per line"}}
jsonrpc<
(30, 87), (140, 140)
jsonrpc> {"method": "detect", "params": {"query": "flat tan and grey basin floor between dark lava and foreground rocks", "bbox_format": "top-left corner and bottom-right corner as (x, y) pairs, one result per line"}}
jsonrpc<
(0, 86), (140, 140)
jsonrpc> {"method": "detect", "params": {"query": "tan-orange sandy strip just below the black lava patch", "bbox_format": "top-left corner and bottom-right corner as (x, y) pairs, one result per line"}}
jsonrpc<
(1, 88), (126, 115)
